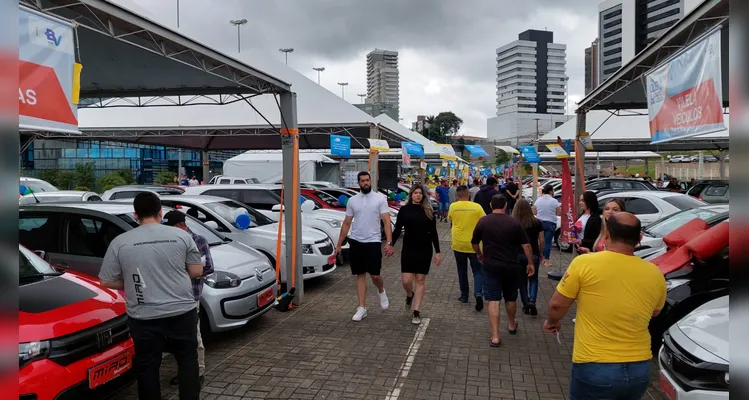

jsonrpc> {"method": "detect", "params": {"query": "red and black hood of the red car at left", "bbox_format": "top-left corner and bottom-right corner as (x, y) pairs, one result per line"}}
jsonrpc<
(18, 271), (125, 343)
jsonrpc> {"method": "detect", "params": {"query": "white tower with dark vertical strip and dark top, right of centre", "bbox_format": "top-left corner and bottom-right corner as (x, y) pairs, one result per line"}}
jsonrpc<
(487, 29), (569, 143)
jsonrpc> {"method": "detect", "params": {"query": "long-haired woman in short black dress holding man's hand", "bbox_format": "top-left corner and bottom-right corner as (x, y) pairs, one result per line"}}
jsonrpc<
(393, 185), (441, 325)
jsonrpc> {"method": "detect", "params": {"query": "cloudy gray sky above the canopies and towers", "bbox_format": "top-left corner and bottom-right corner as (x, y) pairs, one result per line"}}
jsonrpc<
(115, 0), (600, 136)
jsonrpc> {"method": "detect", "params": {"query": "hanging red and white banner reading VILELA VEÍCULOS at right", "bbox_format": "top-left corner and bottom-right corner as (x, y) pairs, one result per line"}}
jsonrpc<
(645, 30), (726, 143)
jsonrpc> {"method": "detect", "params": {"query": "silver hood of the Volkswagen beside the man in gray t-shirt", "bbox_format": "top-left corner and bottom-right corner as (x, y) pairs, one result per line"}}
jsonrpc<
(211, 241), (270, 279)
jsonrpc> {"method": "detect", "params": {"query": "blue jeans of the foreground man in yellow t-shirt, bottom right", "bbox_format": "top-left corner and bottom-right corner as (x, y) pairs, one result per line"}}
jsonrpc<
(570, 360), (650, 400)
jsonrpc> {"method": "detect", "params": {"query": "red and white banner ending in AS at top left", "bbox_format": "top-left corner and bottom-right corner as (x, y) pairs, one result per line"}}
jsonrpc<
(18, 7), (80, 133)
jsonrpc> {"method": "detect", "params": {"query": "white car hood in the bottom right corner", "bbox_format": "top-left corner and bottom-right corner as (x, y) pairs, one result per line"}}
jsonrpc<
(669, 296), (729, 364)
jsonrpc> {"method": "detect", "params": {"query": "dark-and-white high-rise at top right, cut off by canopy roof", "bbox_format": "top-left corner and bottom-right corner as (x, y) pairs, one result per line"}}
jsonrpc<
(598, 0), (703, 83)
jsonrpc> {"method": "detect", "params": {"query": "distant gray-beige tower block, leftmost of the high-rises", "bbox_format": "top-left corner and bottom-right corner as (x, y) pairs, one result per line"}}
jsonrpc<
(367, 49), (400, 121)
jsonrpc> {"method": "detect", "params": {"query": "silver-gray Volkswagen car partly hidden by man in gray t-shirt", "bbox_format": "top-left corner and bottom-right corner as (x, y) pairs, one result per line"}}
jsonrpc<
(18, 202), (276, 332)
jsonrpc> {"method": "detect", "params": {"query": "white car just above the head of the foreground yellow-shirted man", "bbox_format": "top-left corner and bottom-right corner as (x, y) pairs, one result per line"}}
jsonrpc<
(598, 190), (707, 227)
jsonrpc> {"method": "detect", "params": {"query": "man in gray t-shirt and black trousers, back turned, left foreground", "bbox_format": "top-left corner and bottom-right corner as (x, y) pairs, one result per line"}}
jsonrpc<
(99, 192), (204, 400)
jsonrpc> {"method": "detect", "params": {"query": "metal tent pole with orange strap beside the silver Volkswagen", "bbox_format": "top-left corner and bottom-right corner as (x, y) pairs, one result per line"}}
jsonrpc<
(280, 92), (304, 306)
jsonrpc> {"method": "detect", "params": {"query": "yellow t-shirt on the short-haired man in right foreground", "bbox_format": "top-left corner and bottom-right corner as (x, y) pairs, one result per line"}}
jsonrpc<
(557, 251), (666, 363)
